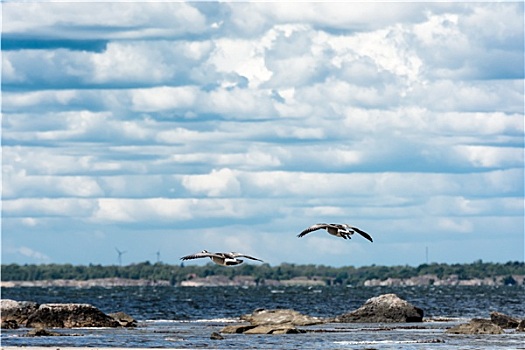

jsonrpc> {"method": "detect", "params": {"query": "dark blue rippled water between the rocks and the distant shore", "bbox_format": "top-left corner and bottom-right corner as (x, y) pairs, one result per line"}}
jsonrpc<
(2, 286), (525, 320)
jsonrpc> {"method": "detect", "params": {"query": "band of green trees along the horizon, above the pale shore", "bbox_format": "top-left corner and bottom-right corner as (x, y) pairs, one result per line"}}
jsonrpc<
(1, 260), (525, 285)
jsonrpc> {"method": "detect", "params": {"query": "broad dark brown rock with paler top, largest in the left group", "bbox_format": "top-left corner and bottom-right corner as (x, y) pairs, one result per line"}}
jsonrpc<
(26, 304), (120, 328)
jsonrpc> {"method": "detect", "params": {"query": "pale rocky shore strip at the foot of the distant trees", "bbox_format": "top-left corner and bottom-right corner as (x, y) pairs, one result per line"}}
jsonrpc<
(0, 275), (525, 288)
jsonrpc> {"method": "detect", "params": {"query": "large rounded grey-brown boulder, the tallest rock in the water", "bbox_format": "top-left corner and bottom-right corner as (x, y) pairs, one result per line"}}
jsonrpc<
(334, 294), (423, 323)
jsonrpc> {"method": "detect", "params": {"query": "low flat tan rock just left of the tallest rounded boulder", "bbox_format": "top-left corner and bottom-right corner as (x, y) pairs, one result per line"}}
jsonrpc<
(241, 309), (326, 326)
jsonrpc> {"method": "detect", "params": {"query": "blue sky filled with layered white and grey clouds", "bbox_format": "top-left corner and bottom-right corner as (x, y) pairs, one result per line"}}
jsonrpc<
(2, 2), (524, 266)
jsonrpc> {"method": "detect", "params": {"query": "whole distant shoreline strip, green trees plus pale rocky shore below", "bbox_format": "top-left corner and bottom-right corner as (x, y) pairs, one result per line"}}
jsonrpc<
(1, 260), (525, 288)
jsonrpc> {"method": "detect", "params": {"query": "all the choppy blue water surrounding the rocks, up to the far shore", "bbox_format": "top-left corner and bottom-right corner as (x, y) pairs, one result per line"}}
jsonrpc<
(1, 286), (525, 350)
